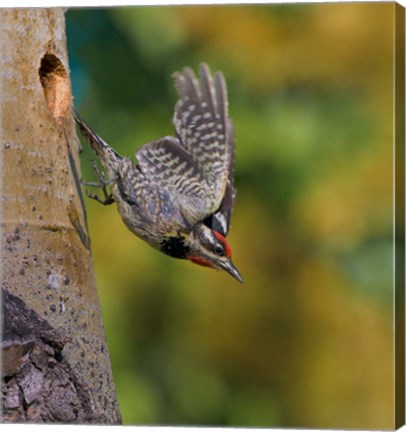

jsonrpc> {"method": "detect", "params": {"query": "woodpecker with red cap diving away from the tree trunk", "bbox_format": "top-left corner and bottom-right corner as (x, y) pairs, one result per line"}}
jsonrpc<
(74, 63), (243, 282)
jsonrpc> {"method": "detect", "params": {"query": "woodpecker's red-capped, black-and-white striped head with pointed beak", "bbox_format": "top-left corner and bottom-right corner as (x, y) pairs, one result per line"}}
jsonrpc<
(186, 224), (243, 283)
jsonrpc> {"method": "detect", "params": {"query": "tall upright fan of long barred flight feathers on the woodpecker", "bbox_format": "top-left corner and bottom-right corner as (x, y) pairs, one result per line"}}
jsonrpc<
(174, 64), (235, 235)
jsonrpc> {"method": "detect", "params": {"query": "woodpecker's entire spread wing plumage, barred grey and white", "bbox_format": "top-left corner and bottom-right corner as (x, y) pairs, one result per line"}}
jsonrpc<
(127, 64), (235, 231)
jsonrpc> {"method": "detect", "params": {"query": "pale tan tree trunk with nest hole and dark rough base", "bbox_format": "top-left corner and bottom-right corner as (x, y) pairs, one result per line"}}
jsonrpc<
(0, 8), (121, 424)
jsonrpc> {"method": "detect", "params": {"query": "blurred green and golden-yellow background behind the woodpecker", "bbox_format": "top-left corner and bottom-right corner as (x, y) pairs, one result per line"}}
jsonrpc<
(66, 3), (394, 429)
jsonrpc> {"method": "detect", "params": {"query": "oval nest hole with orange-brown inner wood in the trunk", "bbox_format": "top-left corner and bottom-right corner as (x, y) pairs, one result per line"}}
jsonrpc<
(38, 53), (71, 122)
